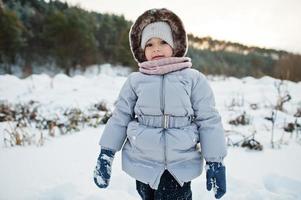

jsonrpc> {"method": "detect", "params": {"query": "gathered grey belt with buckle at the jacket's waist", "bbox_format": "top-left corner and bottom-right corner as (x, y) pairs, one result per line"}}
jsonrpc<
(137, 114), (193, 129)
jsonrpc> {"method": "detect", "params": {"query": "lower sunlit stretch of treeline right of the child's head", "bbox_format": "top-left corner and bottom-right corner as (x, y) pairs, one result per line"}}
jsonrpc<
(188, 34), (301, 81)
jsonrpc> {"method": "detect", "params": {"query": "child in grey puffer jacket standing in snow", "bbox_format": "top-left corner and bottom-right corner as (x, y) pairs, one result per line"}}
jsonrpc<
(94, 9), (227, 200)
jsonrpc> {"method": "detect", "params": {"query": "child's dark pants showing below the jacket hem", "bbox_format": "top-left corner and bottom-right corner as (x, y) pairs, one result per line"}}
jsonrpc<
(136, 170), (192, 200)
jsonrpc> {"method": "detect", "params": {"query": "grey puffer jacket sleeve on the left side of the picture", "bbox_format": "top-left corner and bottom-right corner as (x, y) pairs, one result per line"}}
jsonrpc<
(99, 75), (137, 152)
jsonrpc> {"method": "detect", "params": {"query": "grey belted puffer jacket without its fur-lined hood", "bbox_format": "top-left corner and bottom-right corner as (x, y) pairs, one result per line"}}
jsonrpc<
(99, 68), (227, 189)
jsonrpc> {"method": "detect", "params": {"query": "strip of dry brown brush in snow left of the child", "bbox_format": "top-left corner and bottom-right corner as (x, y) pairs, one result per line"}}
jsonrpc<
(0, 101), (112, 146)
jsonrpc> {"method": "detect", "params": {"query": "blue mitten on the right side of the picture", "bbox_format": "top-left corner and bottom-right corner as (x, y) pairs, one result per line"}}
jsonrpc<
(206, 162), (226, 199)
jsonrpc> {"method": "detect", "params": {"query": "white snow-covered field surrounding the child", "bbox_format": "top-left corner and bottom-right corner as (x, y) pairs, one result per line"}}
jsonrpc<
(0, 66), (301, 200)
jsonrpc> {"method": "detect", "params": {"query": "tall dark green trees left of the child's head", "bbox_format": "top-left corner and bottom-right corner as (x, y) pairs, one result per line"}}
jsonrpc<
(0, 0), (135, 74)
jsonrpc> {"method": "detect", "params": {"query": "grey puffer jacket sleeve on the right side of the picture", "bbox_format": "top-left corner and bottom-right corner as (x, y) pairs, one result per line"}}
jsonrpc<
(191, 73), (227, 162)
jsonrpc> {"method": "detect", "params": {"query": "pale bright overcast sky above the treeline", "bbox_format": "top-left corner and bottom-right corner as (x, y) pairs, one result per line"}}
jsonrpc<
(61, 0), (301, 54)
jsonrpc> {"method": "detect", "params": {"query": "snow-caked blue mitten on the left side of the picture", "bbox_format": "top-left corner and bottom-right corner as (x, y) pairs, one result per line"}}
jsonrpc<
(94, 148), (115, 188)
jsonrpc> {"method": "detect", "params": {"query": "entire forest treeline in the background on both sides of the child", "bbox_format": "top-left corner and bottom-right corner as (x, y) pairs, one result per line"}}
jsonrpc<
(0, 0), (301, 81)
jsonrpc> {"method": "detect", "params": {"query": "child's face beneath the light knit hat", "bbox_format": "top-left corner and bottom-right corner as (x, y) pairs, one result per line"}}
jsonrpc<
(144, 38), (173, 61)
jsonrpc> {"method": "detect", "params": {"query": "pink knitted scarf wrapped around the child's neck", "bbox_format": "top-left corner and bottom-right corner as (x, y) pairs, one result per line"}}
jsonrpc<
(138, 57), (192, 74)
